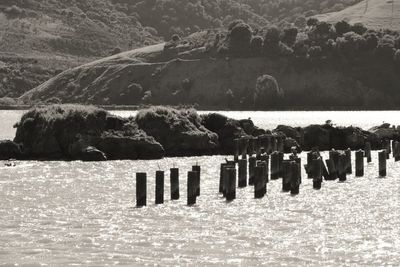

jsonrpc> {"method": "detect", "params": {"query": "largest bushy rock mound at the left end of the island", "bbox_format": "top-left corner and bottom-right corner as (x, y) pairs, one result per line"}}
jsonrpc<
(14, 105), (165, 160)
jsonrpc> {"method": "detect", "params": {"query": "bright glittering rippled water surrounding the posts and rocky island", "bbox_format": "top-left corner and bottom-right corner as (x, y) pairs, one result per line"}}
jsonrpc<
(0, 112), (400, 266)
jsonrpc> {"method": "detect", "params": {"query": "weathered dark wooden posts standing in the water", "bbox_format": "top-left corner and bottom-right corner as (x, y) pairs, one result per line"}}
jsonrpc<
(136, 141), (400, 207)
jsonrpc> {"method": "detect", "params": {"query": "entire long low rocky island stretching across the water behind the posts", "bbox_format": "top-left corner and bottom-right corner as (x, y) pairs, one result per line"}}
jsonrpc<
(0, 105), (400, 161)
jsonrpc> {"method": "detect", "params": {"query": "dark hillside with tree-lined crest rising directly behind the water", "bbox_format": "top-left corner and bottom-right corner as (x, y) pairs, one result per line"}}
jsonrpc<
(20, 15), (400, 109)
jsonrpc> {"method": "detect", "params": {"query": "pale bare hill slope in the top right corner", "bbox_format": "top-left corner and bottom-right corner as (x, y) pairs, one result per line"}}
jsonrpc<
(316, 0), (400, 30)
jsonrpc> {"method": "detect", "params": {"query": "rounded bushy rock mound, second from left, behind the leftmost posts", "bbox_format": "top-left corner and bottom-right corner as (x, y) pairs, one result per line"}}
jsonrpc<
(136, 107), (219, 156)
